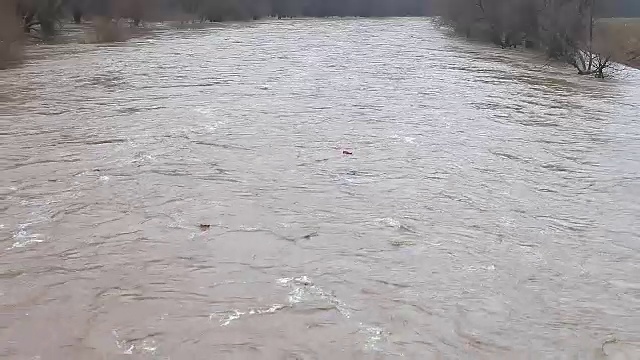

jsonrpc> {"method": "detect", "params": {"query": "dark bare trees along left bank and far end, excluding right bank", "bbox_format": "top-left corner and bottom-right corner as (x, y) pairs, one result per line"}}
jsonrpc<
(0, 0), (432, 68)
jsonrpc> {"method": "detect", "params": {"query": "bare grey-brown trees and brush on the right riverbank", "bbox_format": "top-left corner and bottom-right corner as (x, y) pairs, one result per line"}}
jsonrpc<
(434, 0), (640, 77)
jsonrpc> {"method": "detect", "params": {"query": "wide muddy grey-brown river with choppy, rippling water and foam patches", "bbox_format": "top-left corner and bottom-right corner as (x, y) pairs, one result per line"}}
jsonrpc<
(0, 19), (640, 360)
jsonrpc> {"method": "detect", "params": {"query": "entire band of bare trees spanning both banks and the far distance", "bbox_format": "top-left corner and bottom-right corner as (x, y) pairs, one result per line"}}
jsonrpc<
(0, 0), (640, 73)
